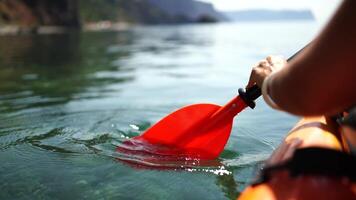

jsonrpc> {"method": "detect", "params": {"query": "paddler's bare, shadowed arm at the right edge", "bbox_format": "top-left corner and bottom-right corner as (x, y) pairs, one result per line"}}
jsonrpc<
(270, 0), (356, 115)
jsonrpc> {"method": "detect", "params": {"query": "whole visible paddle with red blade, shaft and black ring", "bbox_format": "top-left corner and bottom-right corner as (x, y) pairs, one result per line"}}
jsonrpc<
(117, 46), (301, 159)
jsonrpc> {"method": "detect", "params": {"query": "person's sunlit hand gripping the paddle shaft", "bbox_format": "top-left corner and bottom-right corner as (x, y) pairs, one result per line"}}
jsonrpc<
(246, 56), (287, 88)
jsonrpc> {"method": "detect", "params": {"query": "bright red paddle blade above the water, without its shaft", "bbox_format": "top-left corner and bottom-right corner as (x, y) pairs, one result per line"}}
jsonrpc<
(137, 104), (232, 157)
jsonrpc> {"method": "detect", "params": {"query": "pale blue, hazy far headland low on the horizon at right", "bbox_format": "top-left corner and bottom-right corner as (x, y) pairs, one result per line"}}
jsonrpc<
(224, 9), (315, 21)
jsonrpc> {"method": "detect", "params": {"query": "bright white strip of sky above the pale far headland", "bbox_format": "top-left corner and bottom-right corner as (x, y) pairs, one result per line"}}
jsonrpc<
(202, 0), (341, 20)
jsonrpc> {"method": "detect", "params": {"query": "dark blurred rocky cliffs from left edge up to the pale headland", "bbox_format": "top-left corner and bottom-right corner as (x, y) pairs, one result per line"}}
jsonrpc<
(0, 0), (223, 28)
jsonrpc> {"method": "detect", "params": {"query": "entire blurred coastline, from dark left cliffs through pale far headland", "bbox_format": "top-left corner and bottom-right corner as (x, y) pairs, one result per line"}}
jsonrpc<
(0, 0), (315, 34)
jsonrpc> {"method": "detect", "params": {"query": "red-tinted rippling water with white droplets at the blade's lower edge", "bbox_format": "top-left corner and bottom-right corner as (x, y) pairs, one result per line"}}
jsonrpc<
(112, 136), (231, 175)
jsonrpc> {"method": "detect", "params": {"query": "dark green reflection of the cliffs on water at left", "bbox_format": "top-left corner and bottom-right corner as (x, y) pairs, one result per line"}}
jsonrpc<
(0, 34), (133, 112)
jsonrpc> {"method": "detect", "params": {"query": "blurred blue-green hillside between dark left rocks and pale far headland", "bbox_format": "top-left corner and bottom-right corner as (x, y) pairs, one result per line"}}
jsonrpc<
(79, 0), (223, 24)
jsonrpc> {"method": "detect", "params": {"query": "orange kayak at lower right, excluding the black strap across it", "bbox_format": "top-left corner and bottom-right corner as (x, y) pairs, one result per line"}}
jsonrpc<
(238, 117), (356, 200)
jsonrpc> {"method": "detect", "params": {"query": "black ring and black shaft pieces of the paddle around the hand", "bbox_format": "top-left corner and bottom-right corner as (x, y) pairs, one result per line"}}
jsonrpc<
(239, 45), (309, 109)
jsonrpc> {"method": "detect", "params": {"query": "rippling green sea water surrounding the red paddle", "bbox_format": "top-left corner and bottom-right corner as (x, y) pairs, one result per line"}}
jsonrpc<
(0, 22), (318, 199)
